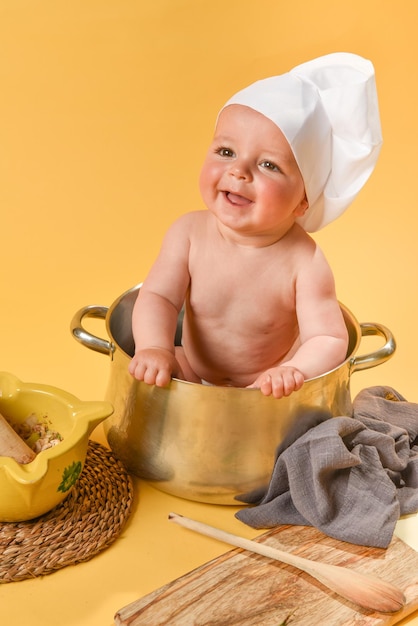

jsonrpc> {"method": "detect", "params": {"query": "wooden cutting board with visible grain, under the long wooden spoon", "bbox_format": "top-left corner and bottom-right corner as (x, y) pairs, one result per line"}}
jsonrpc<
(115, 526), (418, 626)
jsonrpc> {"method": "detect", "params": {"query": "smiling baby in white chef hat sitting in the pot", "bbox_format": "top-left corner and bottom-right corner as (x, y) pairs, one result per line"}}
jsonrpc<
(129, 53), (381, 398)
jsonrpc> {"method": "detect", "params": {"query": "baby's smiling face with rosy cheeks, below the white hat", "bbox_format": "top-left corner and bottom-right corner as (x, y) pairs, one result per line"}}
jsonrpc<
(200, 104), (308, 245)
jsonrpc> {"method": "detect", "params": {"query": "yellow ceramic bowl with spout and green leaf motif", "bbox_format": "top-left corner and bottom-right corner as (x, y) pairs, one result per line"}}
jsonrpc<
(0, 372), (113, 522)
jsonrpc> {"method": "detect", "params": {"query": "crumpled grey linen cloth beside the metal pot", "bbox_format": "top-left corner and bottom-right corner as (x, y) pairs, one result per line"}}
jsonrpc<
(236, 386), (418, 548)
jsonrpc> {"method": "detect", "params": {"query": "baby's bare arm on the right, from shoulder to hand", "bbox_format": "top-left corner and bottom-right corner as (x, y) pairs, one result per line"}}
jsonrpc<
(251, 248), (348, 398)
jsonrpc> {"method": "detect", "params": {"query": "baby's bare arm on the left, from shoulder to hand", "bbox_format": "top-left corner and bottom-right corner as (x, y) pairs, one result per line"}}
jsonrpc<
(129, 216), (190, 387)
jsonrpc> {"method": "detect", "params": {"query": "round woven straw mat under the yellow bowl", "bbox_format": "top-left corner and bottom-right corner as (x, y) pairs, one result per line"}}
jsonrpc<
(0, 440), (133, 583)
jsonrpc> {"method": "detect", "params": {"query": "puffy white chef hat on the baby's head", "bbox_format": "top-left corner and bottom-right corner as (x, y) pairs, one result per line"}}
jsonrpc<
(223, 52), (382, 232)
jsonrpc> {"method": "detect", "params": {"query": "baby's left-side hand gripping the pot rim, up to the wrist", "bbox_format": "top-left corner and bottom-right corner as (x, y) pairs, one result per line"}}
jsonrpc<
(128, 348), (183, 387)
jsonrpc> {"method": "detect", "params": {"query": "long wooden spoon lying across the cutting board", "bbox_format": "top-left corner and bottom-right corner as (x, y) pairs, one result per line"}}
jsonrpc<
(168, 513), (406, 613)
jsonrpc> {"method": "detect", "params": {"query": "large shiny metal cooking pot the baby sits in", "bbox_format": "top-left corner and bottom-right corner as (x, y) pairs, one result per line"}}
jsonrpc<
(71, 285), (395, 505)
